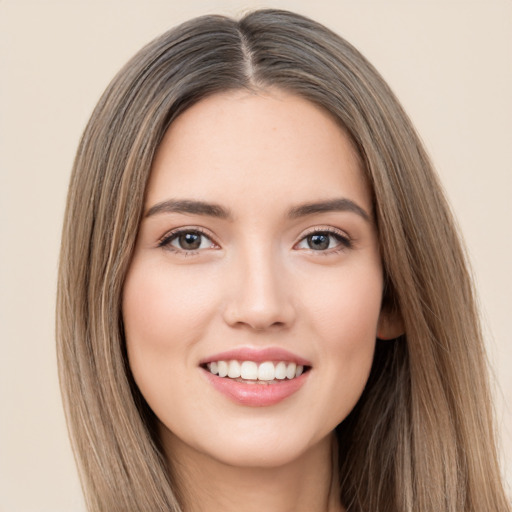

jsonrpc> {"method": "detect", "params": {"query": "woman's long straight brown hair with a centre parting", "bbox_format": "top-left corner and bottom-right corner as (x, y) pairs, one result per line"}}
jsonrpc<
(57, 10), (510, 512)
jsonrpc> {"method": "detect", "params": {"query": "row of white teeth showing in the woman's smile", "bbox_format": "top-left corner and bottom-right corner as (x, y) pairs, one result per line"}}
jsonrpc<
(206, 360), (304, 381)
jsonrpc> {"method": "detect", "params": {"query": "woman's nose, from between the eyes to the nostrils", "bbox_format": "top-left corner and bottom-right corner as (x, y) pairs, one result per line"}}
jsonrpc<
(224, 247), (296, 331)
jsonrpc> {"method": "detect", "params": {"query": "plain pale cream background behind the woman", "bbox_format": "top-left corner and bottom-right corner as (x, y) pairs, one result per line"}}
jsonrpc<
(0, 0), (512, 512)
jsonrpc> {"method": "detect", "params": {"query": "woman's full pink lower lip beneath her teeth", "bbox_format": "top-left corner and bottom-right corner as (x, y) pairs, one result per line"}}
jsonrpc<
(204, 370), (309, 407)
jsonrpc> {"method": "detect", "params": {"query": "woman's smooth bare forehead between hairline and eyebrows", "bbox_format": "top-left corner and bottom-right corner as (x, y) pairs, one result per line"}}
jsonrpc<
(147, 89), (371, 210)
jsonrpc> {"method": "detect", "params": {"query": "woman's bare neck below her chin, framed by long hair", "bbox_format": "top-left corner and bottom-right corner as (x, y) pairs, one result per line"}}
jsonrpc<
(164, 435), (343, 512)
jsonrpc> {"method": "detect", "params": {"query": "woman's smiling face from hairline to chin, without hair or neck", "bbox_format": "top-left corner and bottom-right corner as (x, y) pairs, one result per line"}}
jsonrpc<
(122, 90), (396, 466)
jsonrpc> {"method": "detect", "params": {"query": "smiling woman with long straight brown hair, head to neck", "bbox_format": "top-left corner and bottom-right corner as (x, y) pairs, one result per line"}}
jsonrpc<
(58, 11), (509, 512)
